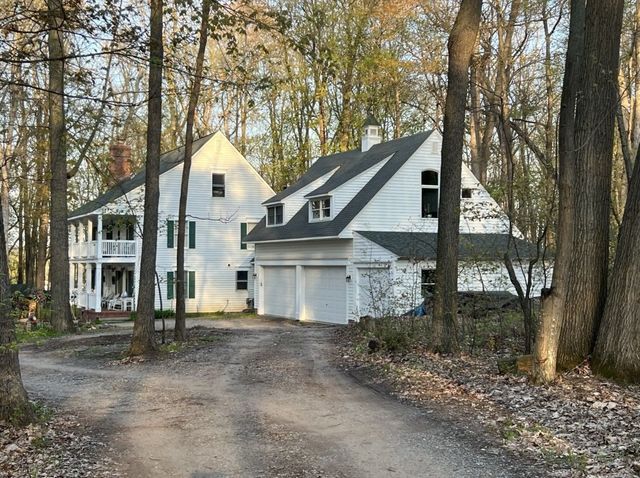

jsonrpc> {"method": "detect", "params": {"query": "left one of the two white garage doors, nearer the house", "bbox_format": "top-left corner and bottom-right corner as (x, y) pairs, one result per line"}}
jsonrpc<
(262, 267), (296, 319)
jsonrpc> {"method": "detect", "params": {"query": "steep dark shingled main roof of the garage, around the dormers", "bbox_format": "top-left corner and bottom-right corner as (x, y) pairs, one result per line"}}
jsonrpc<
(245, 131), (432, 242)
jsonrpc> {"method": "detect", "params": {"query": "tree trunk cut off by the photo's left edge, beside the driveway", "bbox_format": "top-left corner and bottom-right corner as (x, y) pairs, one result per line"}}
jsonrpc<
(0, 187), (34, 425)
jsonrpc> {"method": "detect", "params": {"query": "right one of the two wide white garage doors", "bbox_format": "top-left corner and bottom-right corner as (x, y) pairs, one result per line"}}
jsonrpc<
(302, 267), (347, 324)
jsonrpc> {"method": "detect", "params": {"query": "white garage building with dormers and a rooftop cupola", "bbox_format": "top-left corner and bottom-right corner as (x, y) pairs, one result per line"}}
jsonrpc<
(247, 119), (542, 323)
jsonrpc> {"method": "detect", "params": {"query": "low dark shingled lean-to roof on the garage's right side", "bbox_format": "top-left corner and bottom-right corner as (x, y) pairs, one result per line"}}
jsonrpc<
(356, 231), (537, 260)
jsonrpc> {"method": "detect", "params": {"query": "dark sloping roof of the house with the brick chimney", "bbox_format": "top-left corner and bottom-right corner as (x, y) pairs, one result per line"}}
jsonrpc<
(68, 133), (216, 218)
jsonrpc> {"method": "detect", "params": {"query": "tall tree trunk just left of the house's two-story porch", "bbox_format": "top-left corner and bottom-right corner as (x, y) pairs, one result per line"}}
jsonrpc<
(48, 0), (75, 332)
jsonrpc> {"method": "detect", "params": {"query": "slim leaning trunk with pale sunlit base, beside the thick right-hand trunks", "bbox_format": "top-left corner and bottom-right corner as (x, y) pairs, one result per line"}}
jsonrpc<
(533, 0), (586, 383)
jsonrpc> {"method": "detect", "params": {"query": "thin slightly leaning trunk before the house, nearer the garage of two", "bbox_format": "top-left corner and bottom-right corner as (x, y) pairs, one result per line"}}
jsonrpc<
(173, 0), (211, 341)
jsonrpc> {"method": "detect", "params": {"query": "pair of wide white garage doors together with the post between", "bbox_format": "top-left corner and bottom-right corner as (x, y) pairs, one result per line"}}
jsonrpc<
(259, 265), (347, 324)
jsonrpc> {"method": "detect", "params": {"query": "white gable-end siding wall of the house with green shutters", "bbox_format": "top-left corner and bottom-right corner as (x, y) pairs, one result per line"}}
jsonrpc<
(156, 133), (273, 312)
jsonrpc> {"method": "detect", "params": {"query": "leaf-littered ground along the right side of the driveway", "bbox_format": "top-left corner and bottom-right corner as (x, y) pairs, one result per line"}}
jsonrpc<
(337, 326), (640, 478)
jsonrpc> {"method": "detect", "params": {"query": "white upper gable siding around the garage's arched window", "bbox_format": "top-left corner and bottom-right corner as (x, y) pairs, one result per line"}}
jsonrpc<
(341, 132), (508, 237)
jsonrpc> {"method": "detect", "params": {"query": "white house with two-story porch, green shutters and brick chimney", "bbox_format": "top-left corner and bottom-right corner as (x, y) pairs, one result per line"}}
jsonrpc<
(69, 132), (274, 312)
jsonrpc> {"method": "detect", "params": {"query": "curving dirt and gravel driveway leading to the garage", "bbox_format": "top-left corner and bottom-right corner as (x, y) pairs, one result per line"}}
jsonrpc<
(21, 318), (542, 478)
